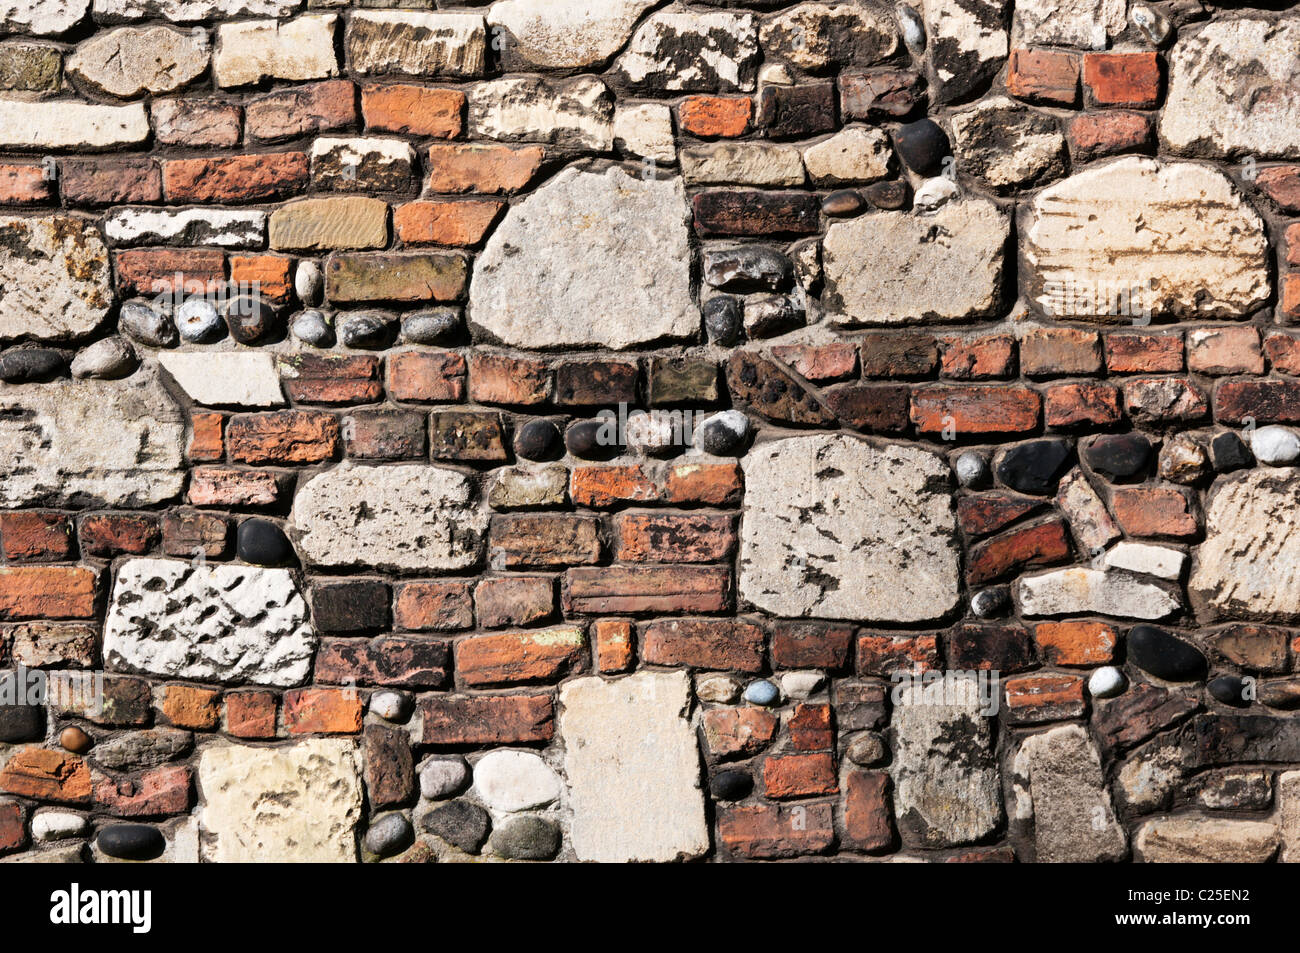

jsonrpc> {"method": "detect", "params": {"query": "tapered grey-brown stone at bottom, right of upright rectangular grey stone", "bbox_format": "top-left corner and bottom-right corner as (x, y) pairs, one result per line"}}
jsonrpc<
(1013, 724), (1126, 863)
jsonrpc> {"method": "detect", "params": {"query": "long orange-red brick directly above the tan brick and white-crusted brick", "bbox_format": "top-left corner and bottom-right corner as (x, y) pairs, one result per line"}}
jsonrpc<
(163, 152), (308, 204)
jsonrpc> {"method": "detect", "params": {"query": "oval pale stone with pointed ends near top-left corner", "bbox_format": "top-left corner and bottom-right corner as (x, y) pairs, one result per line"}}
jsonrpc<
(66, 26), (211, 99)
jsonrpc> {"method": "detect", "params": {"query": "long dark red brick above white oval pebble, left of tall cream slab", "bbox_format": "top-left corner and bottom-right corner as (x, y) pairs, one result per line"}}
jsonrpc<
(420, 694), (555, 745)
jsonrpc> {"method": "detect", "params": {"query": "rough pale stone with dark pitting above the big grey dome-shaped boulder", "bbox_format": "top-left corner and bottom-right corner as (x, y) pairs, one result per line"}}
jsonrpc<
(469, 77), (614, 152)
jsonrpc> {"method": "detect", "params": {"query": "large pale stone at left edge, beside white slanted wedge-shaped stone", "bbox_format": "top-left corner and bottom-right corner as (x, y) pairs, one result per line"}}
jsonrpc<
(0, 368), (185, 507)
